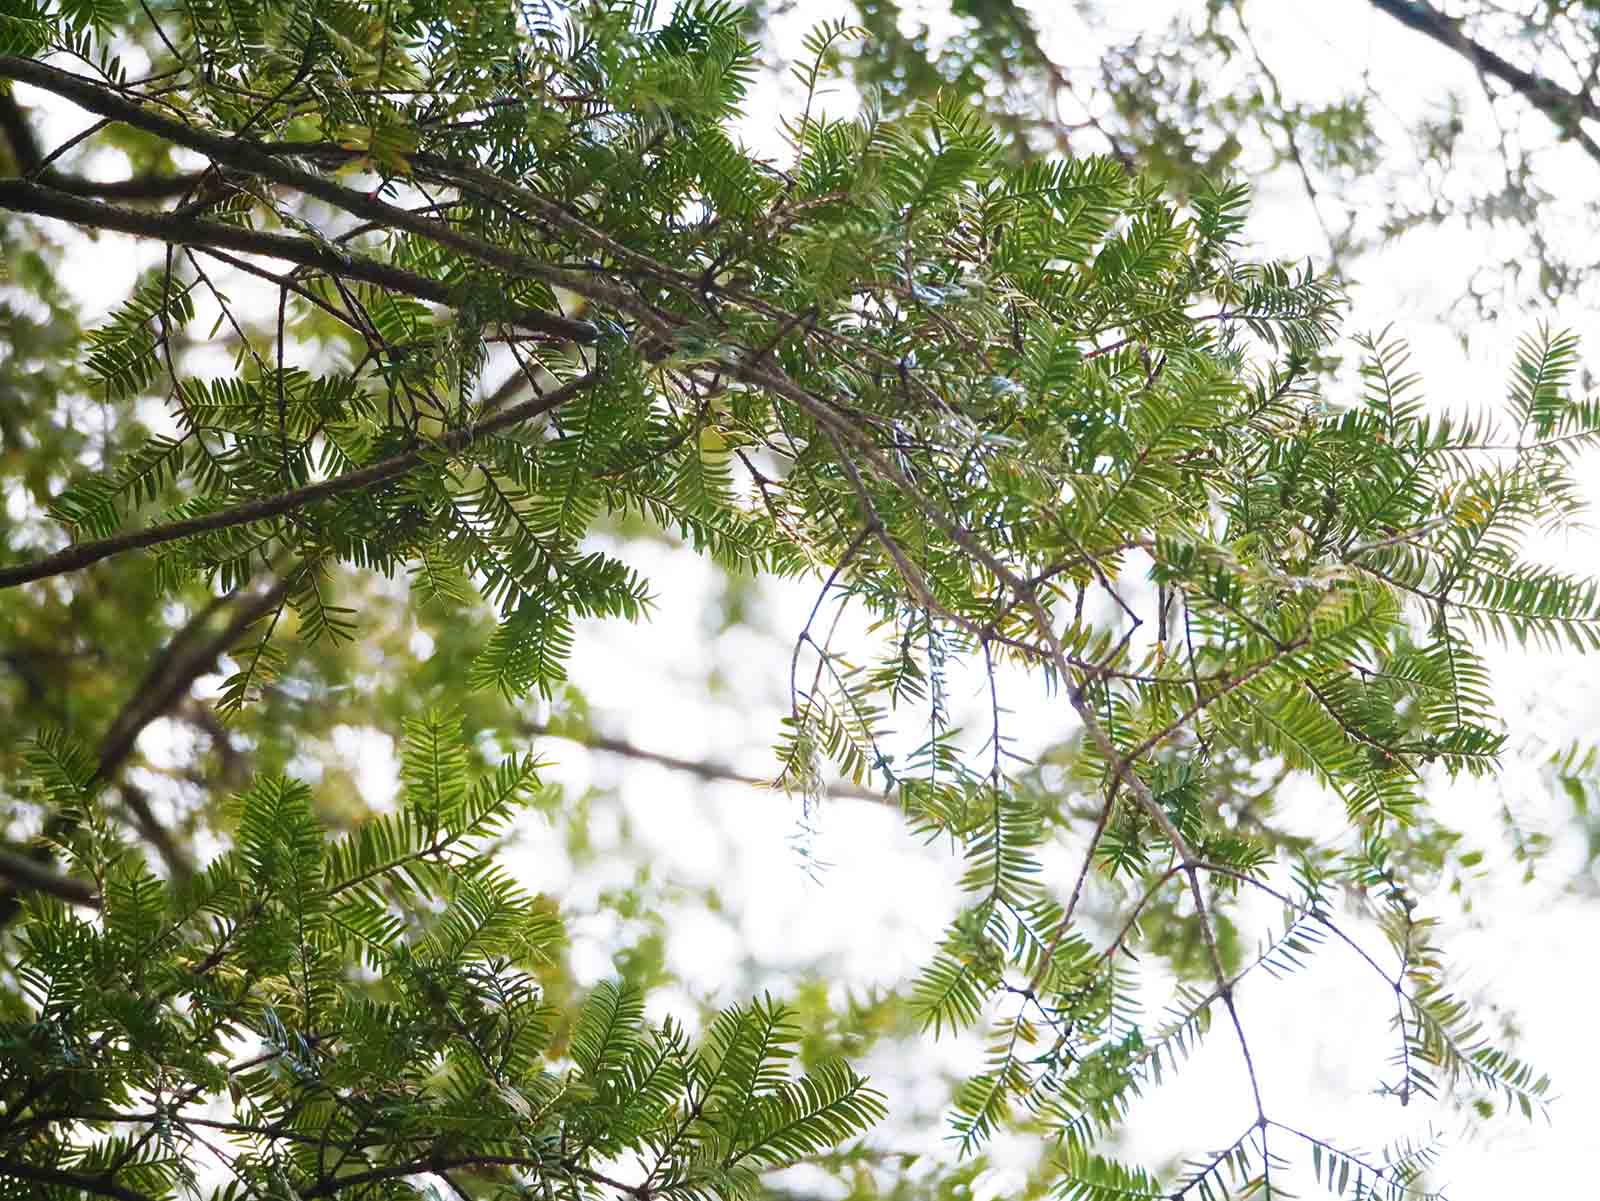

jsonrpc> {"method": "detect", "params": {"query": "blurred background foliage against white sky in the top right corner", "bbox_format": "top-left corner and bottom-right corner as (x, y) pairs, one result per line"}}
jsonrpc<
(832, 0), (1600, 321)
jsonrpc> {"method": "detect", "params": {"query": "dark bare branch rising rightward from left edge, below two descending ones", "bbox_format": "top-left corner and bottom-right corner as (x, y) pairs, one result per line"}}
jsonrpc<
(0, 371), (598, 589)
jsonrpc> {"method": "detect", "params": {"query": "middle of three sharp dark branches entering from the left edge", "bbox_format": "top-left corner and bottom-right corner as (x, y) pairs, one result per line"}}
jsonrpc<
(0, 179), (594, 342)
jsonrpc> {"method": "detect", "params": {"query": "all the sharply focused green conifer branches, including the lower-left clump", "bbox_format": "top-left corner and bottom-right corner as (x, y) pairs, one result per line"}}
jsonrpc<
(0, 0), (1600, 1201)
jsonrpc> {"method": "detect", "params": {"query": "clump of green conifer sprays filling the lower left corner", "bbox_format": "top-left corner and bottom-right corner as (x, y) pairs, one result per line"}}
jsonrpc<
(0, 716), (882, 1201)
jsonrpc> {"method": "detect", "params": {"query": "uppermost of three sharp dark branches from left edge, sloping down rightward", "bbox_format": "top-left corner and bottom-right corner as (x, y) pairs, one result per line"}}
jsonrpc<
(0, 54), (598, 342)
